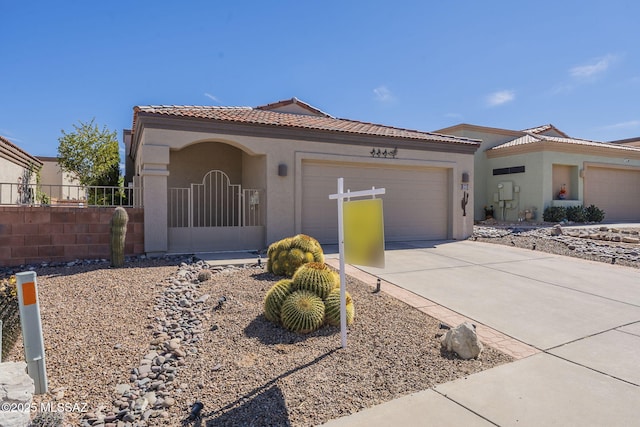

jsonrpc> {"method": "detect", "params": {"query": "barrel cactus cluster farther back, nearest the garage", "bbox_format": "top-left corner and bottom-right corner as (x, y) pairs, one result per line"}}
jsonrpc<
(267, 234), (324, 277)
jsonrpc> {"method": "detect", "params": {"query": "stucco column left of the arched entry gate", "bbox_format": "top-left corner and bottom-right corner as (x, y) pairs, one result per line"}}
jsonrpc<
(140, 144), (169, 256)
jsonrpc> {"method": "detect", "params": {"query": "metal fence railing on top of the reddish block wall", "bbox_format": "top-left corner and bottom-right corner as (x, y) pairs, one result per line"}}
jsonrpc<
(0, 182), (142, 207)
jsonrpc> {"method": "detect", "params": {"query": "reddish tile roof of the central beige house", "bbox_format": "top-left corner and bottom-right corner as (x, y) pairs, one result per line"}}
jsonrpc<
(133, 101), (480, 145)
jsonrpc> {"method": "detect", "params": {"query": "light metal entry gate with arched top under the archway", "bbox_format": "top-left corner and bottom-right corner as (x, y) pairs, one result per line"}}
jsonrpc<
(168, 170), (264, 252)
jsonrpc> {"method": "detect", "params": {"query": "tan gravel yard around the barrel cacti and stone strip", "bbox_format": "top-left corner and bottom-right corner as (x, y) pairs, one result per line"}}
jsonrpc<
(2, 261), (511, 426)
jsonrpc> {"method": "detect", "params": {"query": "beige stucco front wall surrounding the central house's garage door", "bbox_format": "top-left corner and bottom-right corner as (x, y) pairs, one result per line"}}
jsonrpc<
(136, 128), (474, 252)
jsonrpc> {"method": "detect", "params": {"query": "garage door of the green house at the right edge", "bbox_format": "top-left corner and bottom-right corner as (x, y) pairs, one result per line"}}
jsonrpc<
(584, 167), (640, 222)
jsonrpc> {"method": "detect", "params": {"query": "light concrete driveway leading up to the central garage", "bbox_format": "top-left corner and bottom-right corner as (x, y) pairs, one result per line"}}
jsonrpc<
(326, 241), (640, 426)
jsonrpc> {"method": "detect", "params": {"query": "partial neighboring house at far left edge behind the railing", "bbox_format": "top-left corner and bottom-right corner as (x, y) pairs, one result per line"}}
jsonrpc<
(0, 136), (42, 204)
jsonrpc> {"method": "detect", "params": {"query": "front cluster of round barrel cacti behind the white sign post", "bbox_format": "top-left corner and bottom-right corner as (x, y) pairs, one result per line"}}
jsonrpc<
(264, 262), (355, 334)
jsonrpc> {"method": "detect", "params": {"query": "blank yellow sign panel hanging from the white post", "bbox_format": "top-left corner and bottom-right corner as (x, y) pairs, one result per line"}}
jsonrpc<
(343, 199), (384, 267)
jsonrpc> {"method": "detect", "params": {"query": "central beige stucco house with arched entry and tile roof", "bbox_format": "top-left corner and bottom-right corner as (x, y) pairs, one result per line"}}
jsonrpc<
(124, 98), (480, 254)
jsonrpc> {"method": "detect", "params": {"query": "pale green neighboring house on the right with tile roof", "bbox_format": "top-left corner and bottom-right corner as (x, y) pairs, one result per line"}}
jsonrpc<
(437, 124), (640, 221)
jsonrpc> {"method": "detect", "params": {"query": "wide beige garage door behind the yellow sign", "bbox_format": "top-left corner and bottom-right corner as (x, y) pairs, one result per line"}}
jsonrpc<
(302, 162), (450, 244)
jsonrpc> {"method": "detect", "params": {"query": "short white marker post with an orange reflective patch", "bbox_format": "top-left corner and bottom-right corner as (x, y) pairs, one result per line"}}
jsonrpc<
(16, 271), (47, 394)
